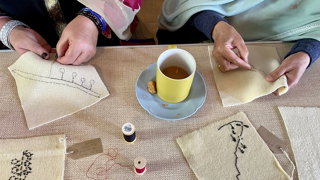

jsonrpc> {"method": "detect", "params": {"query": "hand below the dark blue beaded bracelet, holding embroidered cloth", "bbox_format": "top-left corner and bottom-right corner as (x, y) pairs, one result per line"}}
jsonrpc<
(57, 15), (99, 65)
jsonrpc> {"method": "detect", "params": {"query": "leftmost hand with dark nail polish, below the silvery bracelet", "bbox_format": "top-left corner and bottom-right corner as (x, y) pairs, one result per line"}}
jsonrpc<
(9, 26), (51, 59)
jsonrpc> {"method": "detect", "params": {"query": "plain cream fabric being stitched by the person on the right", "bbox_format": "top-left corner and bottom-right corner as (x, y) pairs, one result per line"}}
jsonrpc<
(209, 45), (288, 107)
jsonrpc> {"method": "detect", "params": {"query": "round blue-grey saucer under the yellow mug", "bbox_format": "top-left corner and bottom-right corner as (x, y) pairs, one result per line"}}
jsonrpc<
(136, 63), (207, 121)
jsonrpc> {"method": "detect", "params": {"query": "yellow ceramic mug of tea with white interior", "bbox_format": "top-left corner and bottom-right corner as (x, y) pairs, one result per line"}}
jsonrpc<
(156, 48), (196, 103)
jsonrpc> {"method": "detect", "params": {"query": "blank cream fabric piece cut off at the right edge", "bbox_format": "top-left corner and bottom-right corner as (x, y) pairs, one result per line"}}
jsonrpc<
(278, 107), (320, 180)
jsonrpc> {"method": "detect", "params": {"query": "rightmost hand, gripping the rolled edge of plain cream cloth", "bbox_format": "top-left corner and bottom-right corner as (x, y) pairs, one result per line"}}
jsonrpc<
(265, 52), (310, 95)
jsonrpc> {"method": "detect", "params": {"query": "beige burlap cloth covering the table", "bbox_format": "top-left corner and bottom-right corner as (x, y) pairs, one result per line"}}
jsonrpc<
(0, 44), (320, 180)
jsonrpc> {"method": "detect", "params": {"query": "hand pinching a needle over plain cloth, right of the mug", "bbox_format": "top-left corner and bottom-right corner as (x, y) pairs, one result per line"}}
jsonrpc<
(212, 21), (251, 72)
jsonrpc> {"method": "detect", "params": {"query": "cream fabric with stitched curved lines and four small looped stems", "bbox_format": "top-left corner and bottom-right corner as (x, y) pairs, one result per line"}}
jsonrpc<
(9, 52), (109, 129)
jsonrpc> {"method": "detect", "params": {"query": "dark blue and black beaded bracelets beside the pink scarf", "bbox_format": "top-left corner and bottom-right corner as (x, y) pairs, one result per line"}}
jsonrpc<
(78, 8), (108, 33)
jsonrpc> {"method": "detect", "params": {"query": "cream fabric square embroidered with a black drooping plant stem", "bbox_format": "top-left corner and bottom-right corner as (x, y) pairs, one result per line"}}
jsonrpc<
(177, 112), (290, 180)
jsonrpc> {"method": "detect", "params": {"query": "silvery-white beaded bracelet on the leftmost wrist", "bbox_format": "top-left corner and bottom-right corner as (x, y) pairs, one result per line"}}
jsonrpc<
(0, 20), (29, 50)
